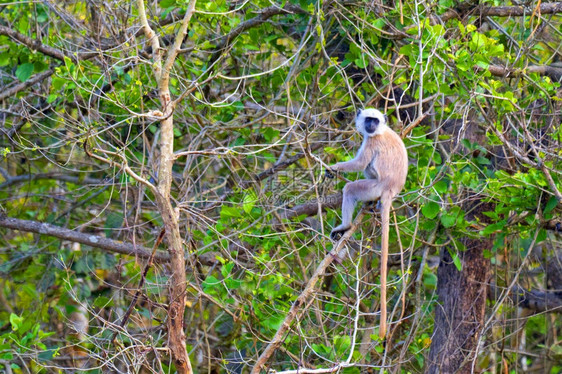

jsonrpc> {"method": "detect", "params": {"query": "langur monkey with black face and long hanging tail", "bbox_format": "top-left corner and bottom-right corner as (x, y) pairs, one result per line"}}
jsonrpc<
(326, 108), (408, 339)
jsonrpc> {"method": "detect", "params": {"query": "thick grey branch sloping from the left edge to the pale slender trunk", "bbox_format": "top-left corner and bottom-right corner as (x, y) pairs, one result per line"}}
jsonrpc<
(0, 213), (169, 262)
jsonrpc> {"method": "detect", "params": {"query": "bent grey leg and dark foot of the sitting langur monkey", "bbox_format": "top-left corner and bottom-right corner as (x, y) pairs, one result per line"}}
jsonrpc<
(330, 179), (383, 240)
